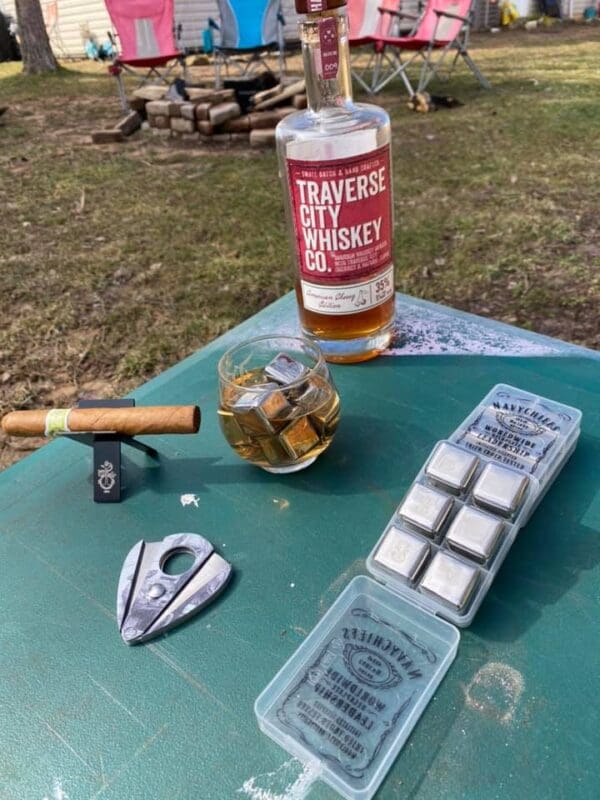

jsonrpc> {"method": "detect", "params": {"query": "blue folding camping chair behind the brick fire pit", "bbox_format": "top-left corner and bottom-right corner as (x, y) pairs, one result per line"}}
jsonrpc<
(209, 0), (285, 88)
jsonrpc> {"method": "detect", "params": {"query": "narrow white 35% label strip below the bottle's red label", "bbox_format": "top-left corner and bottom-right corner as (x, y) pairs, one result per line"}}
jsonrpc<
(300, 264), (394, 314)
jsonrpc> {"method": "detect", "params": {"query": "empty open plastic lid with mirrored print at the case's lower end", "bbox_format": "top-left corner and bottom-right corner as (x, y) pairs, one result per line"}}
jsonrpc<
(255, 576), (460, 800)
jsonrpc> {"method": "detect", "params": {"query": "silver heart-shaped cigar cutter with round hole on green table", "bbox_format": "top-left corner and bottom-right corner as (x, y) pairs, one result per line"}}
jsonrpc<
(117, 533), (232, 644)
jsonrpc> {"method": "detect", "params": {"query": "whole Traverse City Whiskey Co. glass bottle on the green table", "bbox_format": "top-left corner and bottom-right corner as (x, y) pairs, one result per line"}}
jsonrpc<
(277, 0), (394, 362)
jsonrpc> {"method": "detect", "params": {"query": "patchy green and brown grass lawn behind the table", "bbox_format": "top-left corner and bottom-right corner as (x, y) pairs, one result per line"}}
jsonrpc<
(0, 25), (600, 467)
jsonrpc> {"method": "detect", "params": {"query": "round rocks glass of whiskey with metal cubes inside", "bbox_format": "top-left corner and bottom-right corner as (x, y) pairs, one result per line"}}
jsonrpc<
(218, 336), (340, 473)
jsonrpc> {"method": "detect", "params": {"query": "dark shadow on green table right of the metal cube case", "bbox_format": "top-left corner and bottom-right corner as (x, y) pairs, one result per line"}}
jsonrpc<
(471, 434), (600, 641)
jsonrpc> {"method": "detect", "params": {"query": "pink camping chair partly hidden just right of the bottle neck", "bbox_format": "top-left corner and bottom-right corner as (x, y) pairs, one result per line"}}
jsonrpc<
(348, 0), (401, 93)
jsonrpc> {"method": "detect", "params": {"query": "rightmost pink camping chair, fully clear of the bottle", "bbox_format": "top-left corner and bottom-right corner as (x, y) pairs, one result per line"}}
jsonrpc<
(364, 0), (491, 97)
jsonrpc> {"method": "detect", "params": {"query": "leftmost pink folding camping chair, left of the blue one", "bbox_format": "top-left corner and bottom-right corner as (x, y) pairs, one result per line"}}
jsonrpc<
(105, 0), (185, 111)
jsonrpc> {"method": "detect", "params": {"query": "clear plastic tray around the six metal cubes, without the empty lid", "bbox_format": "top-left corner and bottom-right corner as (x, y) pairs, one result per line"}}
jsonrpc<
(367, 384), (581, 627)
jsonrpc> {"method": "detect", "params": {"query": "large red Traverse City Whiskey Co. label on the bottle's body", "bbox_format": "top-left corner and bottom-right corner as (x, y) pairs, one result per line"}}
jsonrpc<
(287, 145), (392, 285)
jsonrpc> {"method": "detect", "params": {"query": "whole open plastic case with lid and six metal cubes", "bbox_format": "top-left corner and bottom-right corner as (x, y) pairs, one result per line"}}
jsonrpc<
(255, 384), (581, 800)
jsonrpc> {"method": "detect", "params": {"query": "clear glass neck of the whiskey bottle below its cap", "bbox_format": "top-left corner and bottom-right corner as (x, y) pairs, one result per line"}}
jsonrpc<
(300, 9), (352, 111)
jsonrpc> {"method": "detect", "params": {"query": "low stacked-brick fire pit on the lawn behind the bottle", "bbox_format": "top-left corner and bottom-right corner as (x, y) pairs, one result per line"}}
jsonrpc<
(92, 80), (306, 147)
